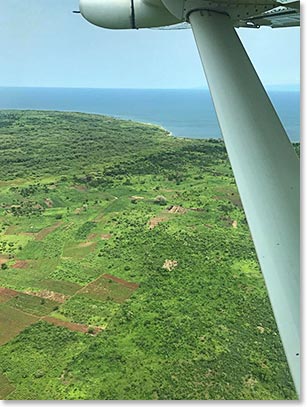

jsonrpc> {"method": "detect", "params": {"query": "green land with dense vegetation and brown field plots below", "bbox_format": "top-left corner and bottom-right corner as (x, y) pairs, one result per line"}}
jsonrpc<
(0, 111), (298, 399)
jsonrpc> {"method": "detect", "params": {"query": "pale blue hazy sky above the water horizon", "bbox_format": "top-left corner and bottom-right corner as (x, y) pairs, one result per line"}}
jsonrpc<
(0, 0), (300, 88)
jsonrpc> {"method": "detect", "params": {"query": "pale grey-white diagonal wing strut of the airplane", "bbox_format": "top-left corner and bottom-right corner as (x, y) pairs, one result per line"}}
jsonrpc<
(188, 9), (300, 394)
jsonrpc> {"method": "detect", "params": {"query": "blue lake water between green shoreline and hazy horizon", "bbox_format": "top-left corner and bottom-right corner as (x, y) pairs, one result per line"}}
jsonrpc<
(0, 88), (300, 141)
